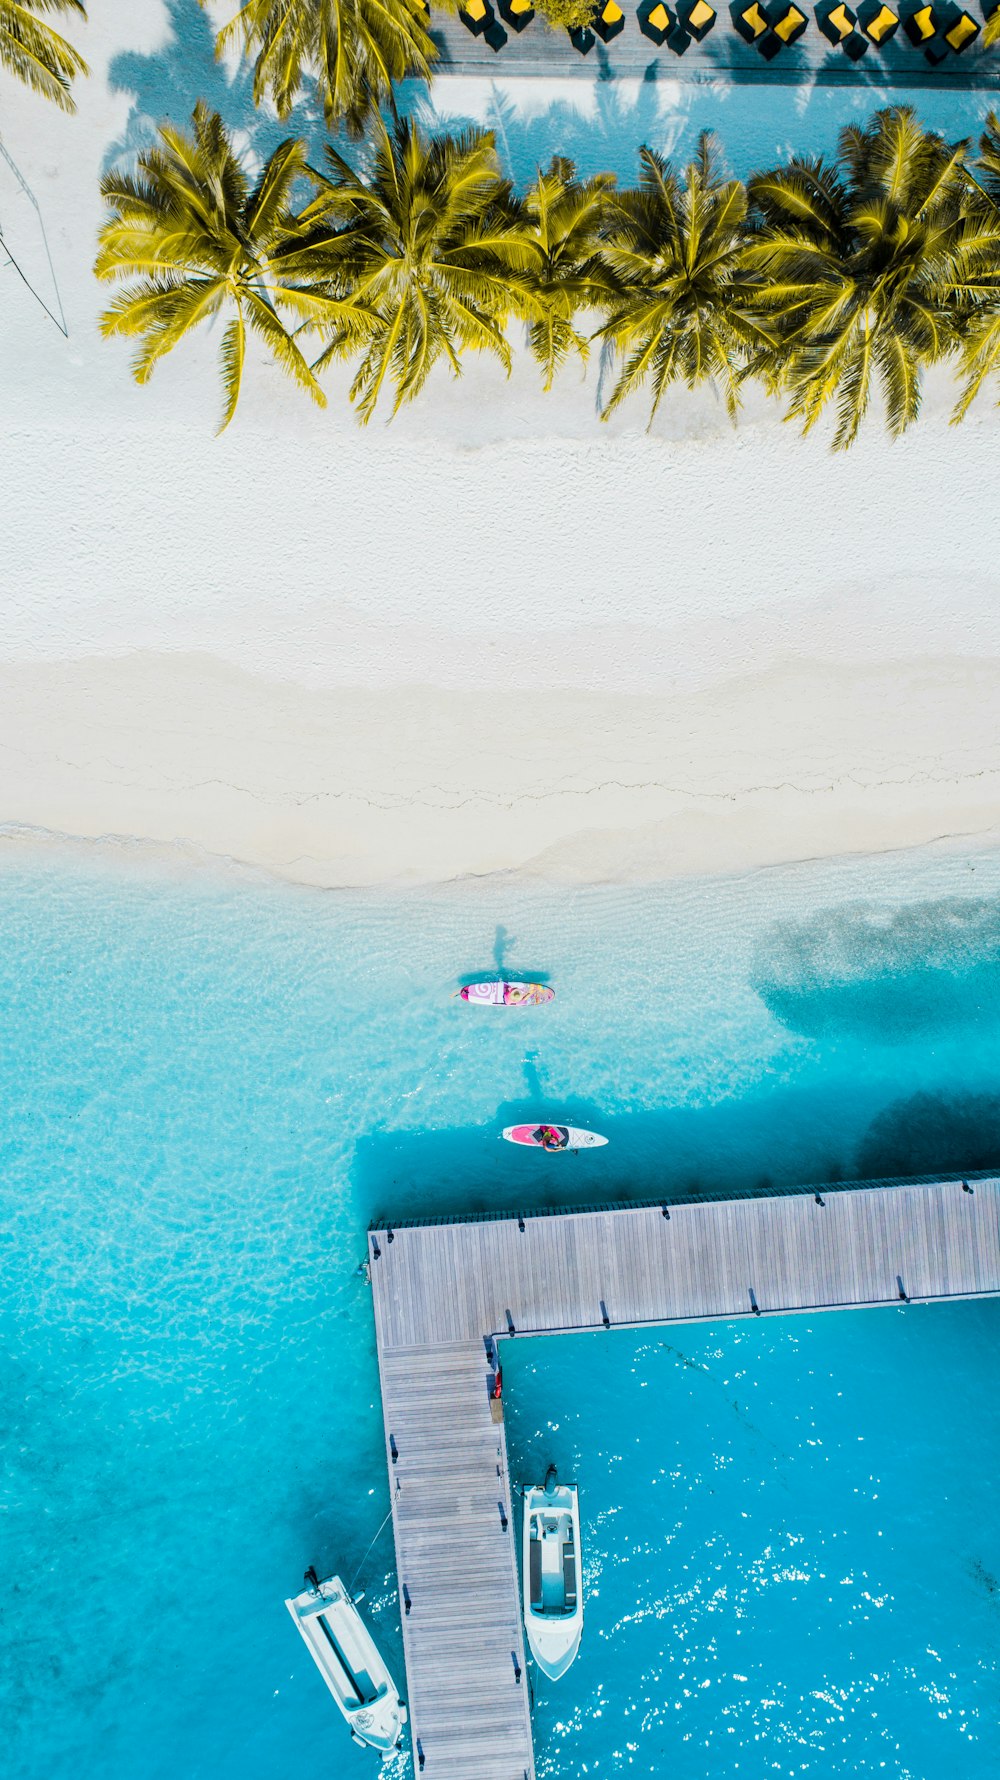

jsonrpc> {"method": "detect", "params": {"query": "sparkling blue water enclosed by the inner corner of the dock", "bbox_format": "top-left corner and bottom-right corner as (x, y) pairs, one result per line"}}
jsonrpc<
(504, 1303), (1000, 1780)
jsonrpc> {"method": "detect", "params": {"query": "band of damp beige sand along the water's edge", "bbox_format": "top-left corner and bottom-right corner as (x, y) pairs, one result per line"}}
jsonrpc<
(0, 657), (1000, 892)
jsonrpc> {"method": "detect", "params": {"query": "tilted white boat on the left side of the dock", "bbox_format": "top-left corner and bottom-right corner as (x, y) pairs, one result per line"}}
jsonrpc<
(285, 1570), (406, 1760)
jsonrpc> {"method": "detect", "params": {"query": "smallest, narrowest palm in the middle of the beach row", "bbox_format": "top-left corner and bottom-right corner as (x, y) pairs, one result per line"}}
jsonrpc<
(525, 158), (616, 390)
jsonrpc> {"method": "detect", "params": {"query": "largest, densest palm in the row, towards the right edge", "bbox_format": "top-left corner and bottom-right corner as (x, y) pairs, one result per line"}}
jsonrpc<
(747, 105), (975, 449)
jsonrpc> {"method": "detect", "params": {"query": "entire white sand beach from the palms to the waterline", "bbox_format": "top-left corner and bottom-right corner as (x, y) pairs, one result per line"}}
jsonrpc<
(0, 0), (1000, 885)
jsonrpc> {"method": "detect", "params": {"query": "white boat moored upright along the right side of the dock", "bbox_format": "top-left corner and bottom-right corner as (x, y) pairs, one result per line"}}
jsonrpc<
(521, 1465), (584, 1680)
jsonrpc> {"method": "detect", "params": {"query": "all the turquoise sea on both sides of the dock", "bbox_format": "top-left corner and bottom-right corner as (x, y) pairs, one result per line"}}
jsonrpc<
(0, 854), (1000, 1780)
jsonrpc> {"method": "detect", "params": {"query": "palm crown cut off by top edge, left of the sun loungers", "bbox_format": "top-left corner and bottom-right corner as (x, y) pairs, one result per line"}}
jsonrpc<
(201, 0), (438, 130)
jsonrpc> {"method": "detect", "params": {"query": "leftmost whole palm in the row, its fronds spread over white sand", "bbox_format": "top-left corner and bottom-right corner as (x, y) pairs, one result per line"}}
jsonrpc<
(94, 101), (365, 431)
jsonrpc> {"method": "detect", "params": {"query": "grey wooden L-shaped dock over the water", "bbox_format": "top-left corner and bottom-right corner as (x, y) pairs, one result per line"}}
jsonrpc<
(368, 1177), (1000, 1780)
